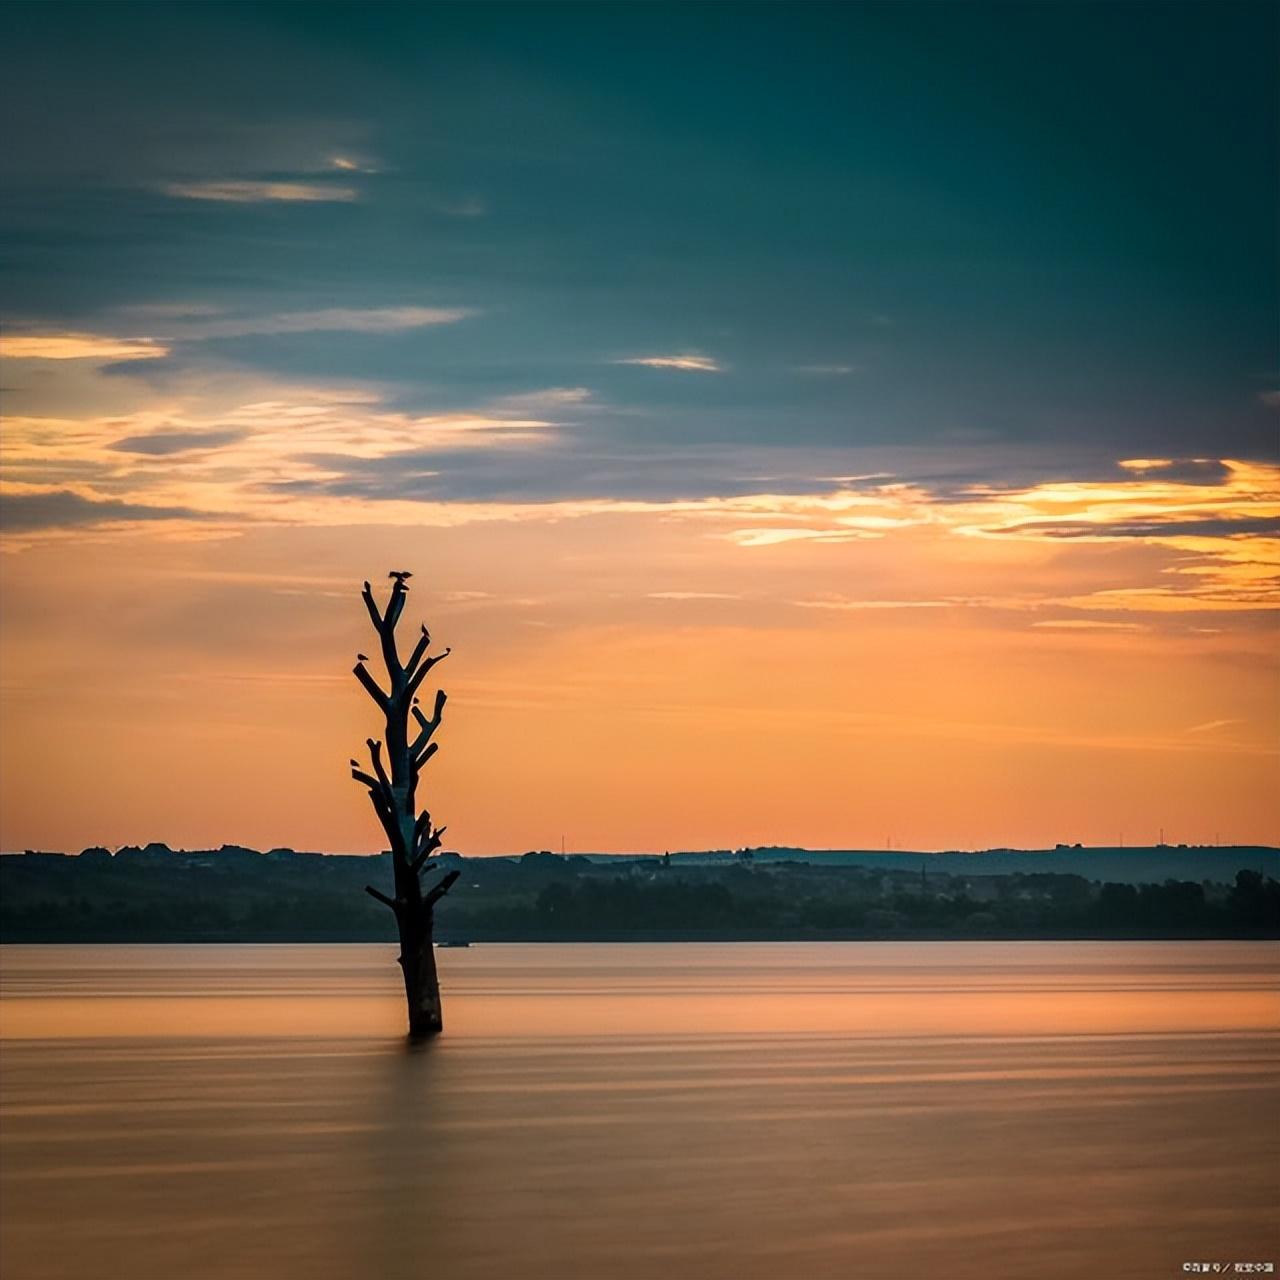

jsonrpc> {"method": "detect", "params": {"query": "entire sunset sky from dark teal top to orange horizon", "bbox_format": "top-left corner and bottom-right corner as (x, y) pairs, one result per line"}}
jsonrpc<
(0, 3), (1280, 854)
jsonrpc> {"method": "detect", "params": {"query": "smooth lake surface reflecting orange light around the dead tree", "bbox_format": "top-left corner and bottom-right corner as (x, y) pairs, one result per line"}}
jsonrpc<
(0, 942), (1280, 1280)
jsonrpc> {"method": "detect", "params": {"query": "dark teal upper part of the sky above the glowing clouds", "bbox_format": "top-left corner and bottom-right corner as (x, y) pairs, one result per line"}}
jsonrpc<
(0, 4), (1277, 500)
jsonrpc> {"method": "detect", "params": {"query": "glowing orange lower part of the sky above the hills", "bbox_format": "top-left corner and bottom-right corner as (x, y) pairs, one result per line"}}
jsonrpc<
(0, 346), (1280, 854)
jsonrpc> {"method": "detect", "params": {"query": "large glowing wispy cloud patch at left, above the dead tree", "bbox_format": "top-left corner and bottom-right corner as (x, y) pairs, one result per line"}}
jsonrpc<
(3, 380), (570, 529)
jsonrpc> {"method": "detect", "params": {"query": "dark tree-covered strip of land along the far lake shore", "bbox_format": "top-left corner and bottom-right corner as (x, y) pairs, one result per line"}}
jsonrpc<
(0, 844), (1280, 942)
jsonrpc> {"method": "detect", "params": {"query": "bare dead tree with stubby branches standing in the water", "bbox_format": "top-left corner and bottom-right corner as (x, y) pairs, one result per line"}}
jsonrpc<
(351, 572), (458, 1038)
